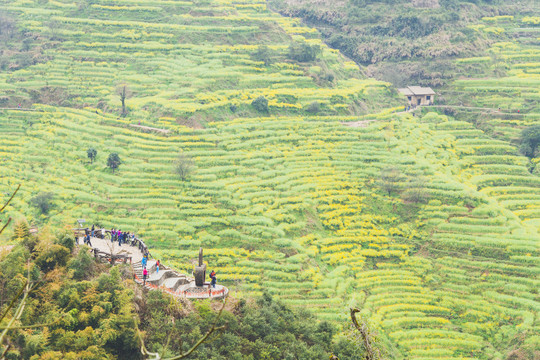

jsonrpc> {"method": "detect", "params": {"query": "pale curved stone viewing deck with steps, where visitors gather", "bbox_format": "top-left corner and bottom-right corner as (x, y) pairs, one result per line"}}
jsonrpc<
(75, 229), (229, 299)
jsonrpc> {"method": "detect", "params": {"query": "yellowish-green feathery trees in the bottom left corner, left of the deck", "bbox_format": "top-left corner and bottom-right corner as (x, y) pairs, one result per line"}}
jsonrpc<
(0, 240), (141, 360)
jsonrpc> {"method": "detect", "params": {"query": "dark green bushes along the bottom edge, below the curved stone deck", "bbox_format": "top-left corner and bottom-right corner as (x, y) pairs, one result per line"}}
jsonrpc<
(137, 292), (355, 360)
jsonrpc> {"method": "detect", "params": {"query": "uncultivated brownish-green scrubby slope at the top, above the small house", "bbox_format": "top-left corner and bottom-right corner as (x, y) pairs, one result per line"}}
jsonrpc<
(268, 0), (538, 87)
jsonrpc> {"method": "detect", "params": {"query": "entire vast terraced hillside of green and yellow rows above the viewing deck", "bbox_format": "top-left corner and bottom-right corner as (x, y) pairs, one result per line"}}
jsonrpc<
(0, 0), (540, 359)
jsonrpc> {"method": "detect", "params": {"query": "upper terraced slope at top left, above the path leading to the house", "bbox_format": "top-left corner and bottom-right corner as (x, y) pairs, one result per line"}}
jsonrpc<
(0, 0), (387, 121)
